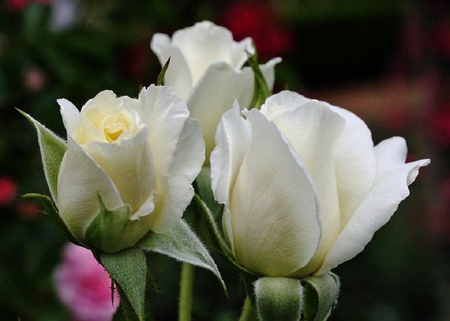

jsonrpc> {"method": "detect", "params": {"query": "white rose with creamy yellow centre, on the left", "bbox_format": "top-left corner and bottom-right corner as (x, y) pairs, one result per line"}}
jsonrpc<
(55, 86), (204, 252)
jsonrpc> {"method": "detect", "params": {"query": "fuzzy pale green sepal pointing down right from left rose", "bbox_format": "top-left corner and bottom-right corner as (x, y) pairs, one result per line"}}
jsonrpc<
(137, 220), (227, 293)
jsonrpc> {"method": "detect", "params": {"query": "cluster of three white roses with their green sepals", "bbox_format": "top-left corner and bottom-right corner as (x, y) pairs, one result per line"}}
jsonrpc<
(25, 21), (429, 320)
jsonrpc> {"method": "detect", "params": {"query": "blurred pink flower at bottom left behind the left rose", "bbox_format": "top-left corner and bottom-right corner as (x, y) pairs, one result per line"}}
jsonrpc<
(55, 243), (119, 321)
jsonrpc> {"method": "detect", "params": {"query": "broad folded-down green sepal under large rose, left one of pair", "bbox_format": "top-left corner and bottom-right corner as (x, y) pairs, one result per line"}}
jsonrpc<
(255, 277), (303, 321)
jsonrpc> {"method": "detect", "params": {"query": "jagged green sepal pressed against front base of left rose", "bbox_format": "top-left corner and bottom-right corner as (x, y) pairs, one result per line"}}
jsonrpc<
(85, 193), (136, 253)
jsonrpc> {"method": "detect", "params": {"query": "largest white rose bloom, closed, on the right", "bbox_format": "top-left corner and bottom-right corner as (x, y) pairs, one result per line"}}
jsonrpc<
(211, 91), (429, 278)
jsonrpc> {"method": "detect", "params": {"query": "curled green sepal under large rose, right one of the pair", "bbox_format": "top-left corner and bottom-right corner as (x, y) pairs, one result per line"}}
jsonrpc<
(303, 272), (340, 321)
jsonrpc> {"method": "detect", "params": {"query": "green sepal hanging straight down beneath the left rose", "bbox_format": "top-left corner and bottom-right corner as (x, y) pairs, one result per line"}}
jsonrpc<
(99, 248), (147, 321)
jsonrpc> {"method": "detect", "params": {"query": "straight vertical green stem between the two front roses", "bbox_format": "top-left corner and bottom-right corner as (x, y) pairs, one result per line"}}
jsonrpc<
(178, 263), (195, 321)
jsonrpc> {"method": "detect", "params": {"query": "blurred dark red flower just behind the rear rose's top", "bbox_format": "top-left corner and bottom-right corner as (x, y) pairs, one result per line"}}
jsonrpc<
(222, 1), (294, 58)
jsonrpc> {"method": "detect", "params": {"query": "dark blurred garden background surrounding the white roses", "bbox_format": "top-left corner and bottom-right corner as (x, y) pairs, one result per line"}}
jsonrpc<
(0, 0), (450, 321)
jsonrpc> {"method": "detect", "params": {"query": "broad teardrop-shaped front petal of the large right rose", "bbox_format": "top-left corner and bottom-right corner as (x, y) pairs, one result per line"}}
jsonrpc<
(212, 106), (320, 276)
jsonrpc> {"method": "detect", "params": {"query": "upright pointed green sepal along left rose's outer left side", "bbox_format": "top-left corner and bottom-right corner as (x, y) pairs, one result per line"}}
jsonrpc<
(17, 109), (67, 203)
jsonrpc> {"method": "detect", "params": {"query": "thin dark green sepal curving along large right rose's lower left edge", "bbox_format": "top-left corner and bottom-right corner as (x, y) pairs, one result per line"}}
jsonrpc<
(194, 194), (254, 275)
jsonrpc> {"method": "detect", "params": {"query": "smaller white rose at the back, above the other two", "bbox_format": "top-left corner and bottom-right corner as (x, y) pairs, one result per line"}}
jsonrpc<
(151, 21), (281, 158)
